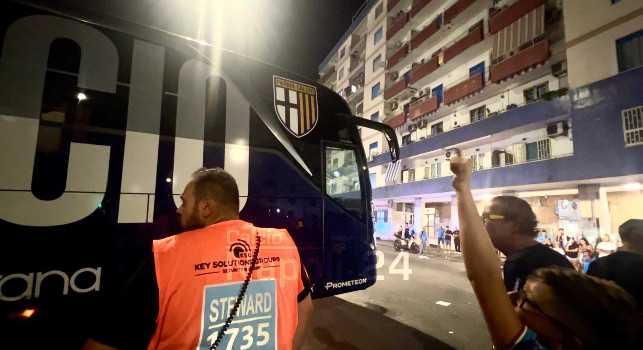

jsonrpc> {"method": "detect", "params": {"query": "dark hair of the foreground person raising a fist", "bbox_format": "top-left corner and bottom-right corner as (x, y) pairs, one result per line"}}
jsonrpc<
(527, 266), (641, 349)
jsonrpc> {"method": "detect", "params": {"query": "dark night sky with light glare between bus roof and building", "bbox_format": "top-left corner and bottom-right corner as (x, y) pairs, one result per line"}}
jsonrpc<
(64, 0), (370, 80)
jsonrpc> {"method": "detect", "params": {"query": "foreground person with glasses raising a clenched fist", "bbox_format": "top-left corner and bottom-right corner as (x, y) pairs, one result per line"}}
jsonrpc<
(450, 157), (641, 349)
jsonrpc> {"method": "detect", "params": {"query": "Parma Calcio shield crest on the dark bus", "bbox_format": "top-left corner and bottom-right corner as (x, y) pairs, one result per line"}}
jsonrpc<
(273, 76), (319, 137)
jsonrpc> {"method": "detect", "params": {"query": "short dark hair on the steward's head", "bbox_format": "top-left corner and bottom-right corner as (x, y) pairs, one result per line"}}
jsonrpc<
(192, 168), (239, 212)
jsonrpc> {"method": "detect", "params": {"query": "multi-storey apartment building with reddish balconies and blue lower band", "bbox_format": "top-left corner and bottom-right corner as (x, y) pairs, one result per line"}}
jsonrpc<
(319, 0), (643, 243)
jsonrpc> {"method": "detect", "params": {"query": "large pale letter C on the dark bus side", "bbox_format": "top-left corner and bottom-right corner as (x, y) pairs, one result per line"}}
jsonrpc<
(0, 15), (118, 226)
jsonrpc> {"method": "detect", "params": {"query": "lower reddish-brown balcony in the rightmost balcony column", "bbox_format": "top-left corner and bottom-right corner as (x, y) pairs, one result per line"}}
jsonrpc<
(489, 39), (549, 83)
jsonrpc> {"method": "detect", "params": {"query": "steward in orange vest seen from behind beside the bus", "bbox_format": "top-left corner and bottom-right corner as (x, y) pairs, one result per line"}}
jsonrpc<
(82, 168), (313, 350)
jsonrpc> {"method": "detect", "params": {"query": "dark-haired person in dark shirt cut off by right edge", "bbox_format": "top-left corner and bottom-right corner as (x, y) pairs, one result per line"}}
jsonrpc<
(587, 219), (643, 311)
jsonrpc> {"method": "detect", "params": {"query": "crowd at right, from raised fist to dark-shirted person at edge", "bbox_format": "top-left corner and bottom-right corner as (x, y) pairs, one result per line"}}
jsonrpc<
(450, 157), (643, 349)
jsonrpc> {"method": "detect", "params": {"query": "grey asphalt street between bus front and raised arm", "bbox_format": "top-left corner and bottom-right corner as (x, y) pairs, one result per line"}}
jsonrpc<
(303, 241), (500, 350)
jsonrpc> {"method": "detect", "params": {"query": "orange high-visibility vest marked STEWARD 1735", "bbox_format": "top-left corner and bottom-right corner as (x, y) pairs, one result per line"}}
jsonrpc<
(148, 220), (304, 350)
